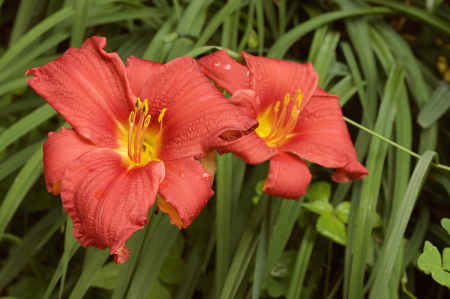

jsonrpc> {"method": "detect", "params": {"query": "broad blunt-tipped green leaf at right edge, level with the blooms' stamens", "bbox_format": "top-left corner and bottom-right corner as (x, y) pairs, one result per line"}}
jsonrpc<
(417, 80), (450, 129)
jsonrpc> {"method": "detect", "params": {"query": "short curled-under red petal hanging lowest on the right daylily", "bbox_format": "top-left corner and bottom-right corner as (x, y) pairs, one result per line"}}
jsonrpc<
(263, 152), (311, 200)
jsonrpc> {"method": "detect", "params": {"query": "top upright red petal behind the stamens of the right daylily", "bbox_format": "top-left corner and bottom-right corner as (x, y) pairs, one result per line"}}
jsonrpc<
(242, 52), (319, 110)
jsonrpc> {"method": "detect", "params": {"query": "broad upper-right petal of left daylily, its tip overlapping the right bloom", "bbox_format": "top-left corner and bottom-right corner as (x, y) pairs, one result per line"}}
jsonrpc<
(141, 57), (258, 161)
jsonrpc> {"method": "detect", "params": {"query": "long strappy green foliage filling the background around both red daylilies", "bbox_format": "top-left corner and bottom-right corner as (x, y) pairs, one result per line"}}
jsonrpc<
(0, 0), (450, 299)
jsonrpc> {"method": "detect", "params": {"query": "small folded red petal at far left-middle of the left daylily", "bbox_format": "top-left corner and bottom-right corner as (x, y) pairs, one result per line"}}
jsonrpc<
(44, 128), (98, 195)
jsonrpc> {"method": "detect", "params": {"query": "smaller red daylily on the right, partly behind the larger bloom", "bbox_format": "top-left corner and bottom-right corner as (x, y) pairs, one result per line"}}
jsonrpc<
(198, 50), (368, 199)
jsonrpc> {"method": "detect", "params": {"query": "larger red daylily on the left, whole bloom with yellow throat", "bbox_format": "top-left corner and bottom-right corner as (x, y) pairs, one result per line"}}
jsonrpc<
(25, 37), (257, 263)
